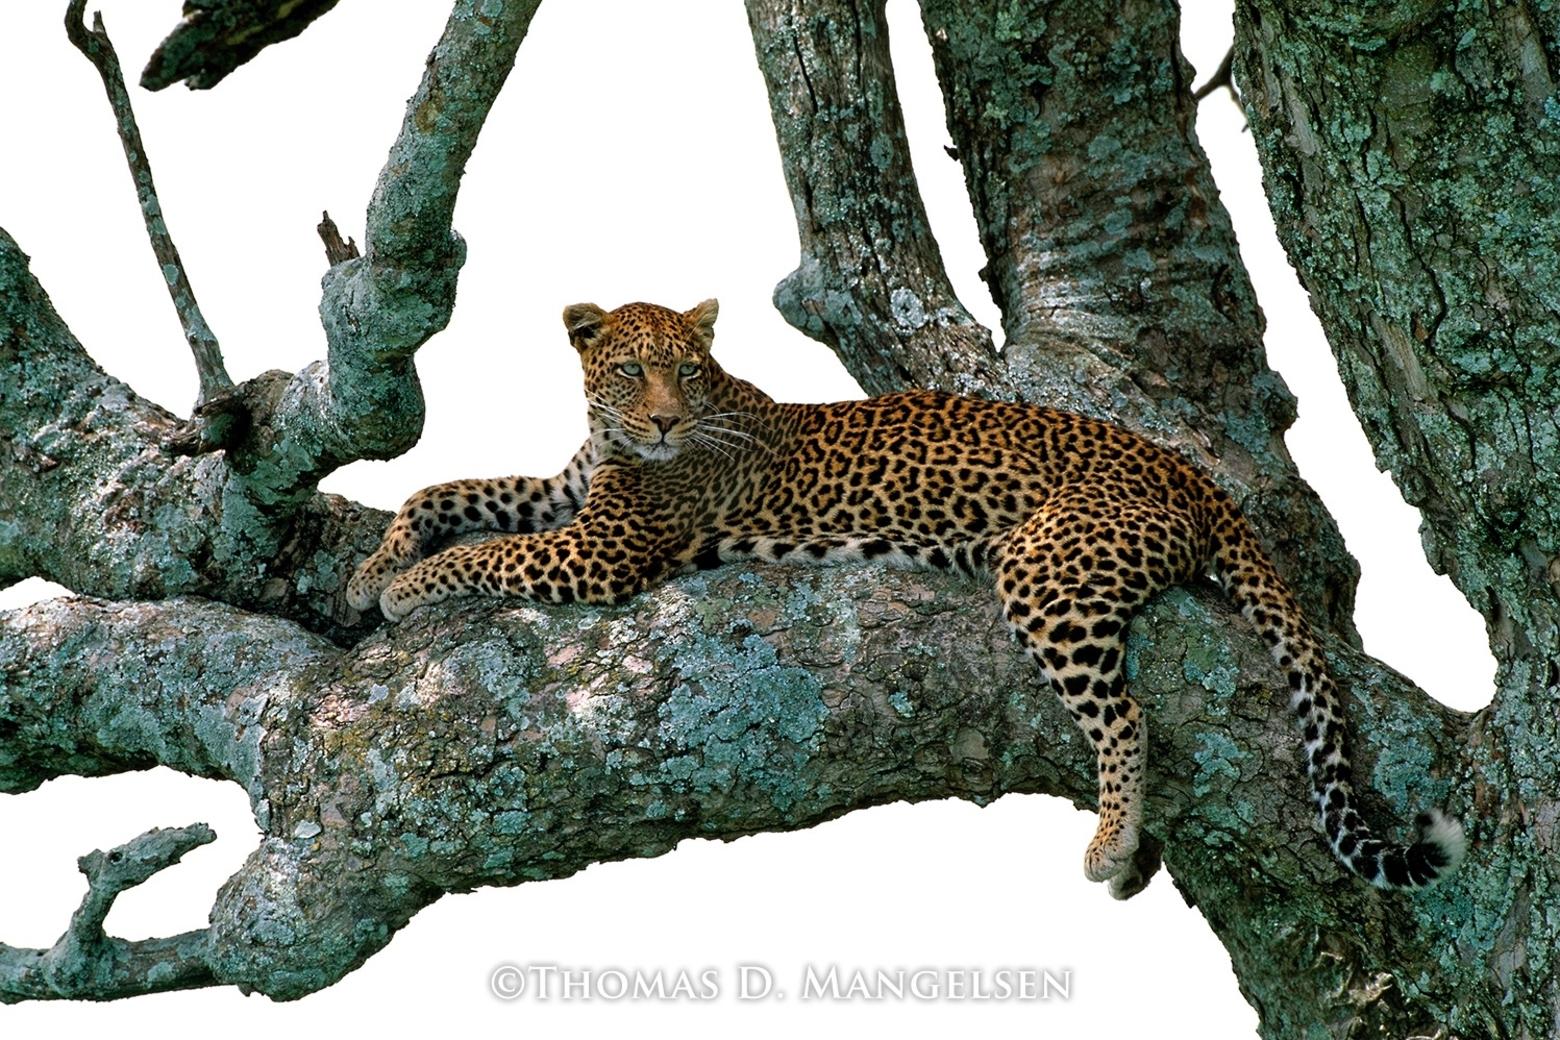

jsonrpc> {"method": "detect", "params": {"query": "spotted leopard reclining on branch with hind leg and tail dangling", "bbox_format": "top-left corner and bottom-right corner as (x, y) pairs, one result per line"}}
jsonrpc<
(346, 299), (1465, 898)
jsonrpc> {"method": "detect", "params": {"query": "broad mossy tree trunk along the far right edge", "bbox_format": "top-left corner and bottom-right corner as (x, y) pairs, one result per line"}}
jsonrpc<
(1236, 0), (1560, 1037)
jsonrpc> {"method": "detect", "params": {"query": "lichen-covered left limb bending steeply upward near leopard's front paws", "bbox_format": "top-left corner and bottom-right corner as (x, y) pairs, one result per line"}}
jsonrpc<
(0, 0), (537, 635)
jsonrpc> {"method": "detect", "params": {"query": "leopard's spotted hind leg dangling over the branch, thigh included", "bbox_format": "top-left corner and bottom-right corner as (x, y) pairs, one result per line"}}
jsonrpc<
(995, 499), (1198, 898)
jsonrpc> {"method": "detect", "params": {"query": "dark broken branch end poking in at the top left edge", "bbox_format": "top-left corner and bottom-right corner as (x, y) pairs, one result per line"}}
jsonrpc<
(140, 0), (337, 90)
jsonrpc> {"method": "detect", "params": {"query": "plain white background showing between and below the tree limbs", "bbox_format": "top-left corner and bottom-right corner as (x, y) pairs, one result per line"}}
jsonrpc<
(0, 0), (1493, 1040)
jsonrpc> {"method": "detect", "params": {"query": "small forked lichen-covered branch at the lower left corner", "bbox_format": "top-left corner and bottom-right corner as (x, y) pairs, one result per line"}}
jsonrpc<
(0, 823), (217, 1003)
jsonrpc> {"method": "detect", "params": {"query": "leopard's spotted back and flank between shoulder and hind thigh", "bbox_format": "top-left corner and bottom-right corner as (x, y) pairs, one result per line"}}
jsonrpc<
(690, 390), (1223, 586)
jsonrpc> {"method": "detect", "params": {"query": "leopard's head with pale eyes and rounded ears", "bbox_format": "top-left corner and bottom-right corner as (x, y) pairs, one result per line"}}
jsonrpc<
(563, 299), (721, 462)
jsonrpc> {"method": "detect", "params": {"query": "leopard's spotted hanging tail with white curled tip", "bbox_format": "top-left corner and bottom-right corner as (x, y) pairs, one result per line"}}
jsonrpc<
(1212, 505), (1465, 889)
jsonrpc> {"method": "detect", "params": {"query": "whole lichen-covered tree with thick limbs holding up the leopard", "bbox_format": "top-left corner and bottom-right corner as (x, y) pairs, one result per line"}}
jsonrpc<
(0, 0), (1560, 1037)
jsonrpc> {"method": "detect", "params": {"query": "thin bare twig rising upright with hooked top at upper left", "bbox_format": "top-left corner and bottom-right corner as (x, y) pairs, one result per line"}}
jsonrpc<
(66, 0), (232, 407)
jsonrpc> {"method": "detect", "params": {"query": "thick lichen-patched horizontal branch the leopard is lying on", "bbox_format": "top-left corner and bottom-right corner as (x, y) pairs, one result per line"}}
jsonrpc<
(0, 566), (1480, 1006)
